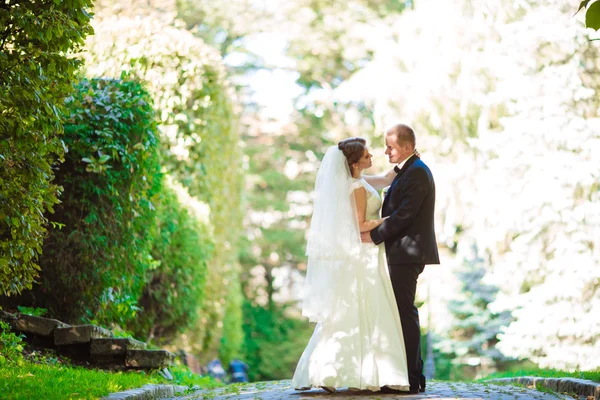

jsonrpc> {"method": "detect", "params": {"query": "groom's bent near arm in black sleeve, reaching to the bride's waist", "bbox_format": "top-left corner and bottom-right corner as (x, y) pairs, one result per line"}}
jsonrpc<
(371, 168), (429, 244)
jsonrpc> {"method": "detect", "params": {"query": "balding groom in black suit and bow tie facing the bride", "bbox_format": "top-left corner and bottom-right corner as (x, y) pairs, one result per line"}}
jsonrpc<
(361, 124), (440, 393)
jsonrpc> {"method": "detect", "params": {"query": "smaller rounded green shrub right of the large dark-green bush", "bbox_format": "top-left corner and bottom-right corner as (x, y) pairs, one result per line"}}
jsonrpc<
(129, 180), (214, 343)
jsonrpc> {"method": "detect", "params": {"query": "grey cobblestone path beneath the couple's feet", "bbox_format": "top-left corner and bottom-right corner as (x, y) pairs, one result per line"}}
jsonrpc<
(165, 380), (573, 400)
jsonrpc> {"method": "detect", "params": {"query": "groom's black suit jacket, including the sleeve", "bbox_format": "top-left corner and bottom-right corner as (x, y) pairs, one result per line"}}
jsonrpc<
(371, 155), (440, 265)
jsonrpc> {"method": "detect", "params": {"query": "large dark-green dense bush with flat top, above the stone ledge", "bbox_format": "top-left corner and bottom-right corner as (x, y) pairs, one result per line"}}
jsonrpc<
(20, 79), (160, 325)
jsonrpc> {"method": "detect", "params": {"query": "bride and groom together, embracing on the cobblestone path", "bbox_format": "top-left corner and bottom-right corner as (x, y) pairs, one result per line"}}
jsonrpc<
(292, 124), (439, 393)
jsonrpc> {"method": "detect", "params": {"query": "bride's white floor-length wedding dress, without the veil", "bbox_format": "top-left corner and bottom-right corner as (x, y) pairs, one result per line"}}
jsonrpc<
(292, 178), (409, 391)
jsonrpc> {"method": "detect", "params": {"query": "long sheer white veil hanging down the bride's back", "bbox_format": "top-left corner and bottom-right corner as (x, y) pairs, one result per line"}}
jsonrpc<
(302, 146), (361, 322)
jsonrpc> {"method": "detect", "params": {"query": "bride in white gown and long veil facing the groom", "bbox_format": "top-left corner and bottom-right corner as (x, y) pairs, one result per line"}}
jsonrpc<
(292, 138), (409, 392)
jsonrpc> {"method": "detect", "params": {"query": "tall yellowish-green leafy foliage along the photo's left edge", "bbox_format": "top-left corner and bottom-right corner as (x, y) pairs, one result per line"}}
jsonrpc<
(0, 0), (92, 295)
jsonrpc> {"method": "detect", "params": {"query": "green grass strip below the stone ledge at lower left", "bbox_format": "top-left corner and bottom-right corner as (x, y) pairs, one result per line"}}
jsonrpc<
(0, 361), (220, 400)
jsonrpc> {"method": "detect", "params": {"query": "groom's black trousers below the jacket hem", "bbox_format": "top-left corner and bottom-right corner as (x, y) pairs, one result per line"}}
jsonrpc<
(389, 264), (425, 390)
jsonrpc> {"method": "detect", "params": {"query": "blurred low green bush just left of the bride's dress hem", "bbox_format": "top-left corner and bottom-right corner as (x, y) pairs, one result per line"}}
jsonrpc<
(243, 301), (314, 381)
